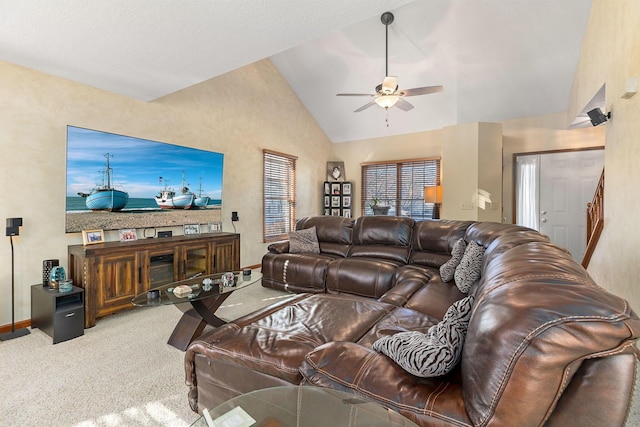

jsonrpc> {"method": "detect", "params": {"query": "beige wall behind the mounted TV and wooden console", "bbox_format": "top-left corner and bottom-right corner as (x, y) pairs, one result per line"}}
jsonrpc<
(0, 60), (332, 325)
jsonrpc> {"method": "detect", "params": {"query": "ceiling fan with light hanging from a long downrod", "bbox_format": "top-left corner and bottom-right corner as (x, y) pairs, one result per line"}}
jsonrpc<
(336, 12), (443, 113)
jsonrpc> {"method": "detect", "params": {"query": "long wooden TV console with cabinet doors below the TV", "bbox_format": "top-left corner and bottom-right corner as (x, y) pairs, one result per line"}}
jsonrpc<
(68, 233), (240, 328)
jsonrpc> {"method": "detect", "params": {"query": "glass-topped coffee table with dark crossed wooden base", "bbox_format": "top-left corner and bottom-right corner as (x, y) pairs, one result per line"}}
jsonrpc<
(131, 268), (262, 351)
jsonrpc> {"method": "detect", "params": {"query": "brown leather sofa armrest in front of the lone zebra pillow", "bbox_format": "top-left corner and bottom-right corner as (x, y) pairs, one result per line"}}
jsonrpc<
(300, 342), (471, 426)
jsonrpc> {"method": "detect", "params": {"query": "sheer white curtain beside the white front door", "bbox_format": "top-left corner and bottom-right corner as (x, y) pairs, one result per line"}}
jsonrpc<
(516, 155), (540, 230)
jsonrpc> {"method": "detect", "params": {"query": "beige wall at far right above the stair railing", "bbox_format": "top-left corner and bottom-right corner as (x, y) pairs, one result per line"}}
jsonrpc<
(569, 0), (640, 312)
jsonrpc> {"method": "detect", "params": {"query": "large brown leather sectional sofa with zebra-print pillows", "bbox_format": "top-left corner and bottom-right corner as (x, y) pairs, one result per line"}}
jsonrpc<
(185, 216), (640, 426)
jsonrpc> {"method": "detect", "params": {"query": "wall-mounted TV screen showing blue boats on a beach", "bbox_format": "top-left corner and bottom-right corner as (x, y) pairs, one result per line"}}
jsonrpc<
(65, 126), (224, 237)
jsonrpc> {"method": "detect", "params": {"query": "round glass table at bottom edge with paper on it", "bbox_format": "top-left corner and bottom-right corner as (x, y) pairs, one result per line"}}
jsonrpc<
(192, 386), (417, 427)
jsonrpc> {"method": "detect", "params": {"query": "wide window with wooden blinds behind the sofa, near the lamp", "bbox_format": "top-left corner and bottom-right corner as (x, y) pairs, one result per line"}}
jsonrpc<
(360, 158), (440, 220)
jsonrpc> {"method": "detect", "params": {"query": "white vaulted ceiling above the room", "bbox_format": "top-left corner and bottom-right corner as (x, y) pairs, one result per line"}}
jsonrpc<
(0, 0), (591, 142)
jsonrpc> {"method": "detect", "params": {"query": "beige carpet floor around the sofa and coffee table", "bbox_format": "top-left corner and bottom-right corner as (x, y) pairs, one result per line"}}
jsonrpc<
(0, 284), (640, 427)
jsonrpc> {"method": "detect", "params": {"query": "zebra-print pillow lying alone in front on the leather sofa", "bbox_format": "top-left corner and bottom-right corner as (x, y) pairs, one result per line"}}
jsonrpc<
(373, 296), (473, 378)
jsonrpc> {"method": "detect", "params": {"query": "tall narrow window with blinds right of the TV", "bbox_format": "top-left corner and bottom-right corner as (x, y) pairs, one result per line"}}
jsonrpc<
(262, 150), (297, 242)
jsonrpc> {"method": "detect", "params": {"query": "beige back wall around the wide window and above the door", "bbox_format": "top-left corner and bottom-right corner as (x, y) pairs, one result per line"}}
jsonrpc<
(333, 113), (605, 226)
